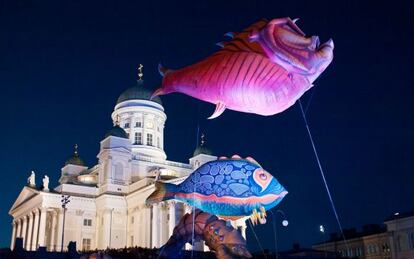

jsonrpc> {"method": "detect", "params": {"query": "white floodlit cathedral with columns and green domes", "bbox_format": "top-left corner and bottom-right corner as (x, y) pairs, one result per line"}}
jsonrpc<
(9, 80), (246, 251)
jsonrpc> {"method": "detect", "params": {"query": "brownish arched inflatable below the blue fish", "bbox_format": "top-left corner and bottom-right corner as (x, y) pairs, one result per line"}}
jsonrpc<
(160, 209), (252, 259)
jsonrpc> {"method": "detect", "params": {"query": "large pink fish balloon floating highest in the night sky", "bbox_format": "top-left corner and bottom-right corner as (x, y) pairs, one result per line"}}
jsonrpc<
(153, 18), (334, 119)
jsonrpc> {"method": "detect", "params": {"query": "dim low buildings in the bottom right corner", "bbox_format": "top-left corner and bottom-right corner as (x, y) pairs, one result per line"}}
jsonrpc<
(312, 212), (414, 259)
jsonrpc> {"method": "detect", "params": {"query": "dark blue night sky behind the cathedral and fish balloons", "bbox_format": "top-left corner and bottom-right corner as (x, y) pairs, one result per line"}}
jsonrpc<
(0, 0), (414, 251)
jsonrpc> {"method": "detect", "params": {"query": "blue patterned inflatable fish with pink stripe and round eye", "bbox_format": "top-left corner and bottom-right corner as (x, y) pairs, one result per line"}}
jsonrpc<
(146, 155), (288, 224)
